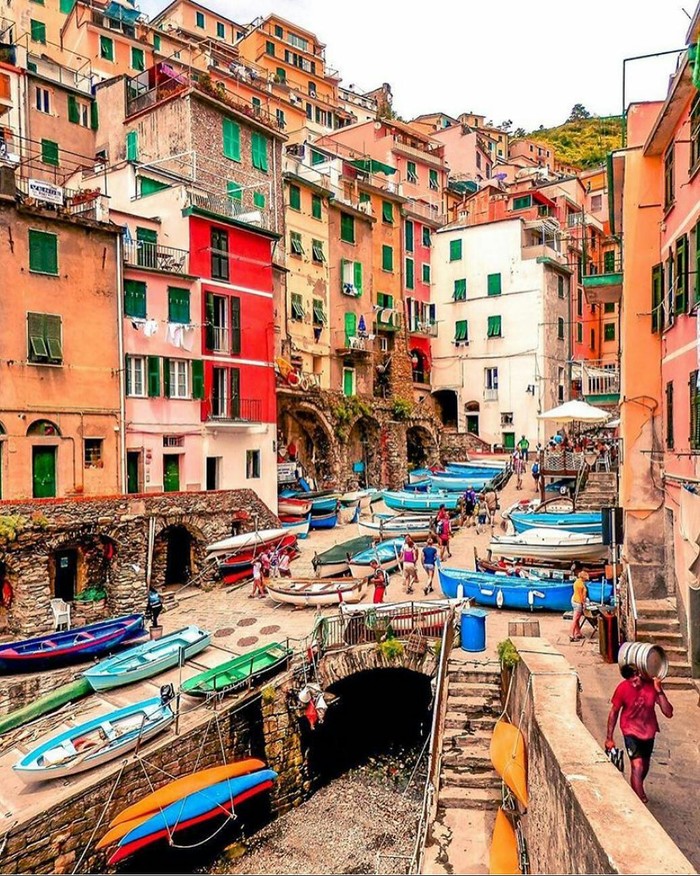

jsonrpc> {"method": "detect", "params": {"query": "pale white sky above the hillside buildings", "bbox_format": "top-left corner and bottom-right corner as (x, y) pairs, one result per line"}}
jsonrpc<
(137, 0), (697, 130)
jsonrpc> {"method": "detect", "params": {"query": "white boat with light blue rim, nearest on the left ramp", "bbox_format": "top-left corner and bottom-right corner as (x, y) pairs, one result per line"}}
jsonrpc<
(12, 697), (175, 784)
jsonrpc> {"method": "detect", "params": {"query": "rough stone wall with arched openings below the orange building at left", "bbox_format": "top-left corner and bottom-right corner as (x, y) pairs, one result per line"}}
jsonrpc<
(0, 490), (277, 637)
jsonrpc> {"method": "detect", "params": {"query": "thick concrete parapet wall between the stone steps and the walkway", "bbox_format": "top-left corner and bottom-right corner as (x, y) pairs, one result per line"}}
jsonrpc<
(509, 637), (695, 874)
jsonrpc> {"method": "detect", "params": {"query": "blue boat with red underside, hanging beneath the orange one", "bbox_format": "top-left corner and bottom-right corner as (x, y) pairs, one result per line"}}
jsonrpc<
(108, 769), (277, 865)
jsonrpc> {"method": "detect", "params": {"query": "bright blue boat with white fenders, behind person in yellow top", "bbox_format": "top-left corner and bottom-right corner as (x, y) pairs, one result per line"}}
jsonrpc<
(438, 566), (613, 611)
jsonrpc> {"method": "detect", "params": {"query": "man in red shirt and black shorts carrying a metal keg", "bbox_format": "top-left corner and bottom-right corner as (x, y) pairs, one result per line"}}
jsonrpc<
(605, 666), (673, 803)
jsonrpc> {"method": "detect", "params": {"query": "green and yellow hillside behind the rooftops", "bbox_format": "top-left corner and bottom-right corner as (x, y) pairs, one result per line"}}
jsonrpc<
(526, 116), (622, 169)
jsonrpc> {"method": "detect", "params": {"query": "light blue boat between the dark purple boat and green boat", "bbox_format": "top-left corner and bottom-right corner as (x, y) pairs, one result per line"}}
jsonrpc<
(83, 624), (211, 690)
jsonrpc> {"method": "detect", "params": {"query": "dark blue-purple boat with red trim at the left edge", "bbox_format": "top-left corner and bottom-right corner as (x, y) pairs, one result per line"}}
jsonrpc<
(0, 614), (146, 673)
